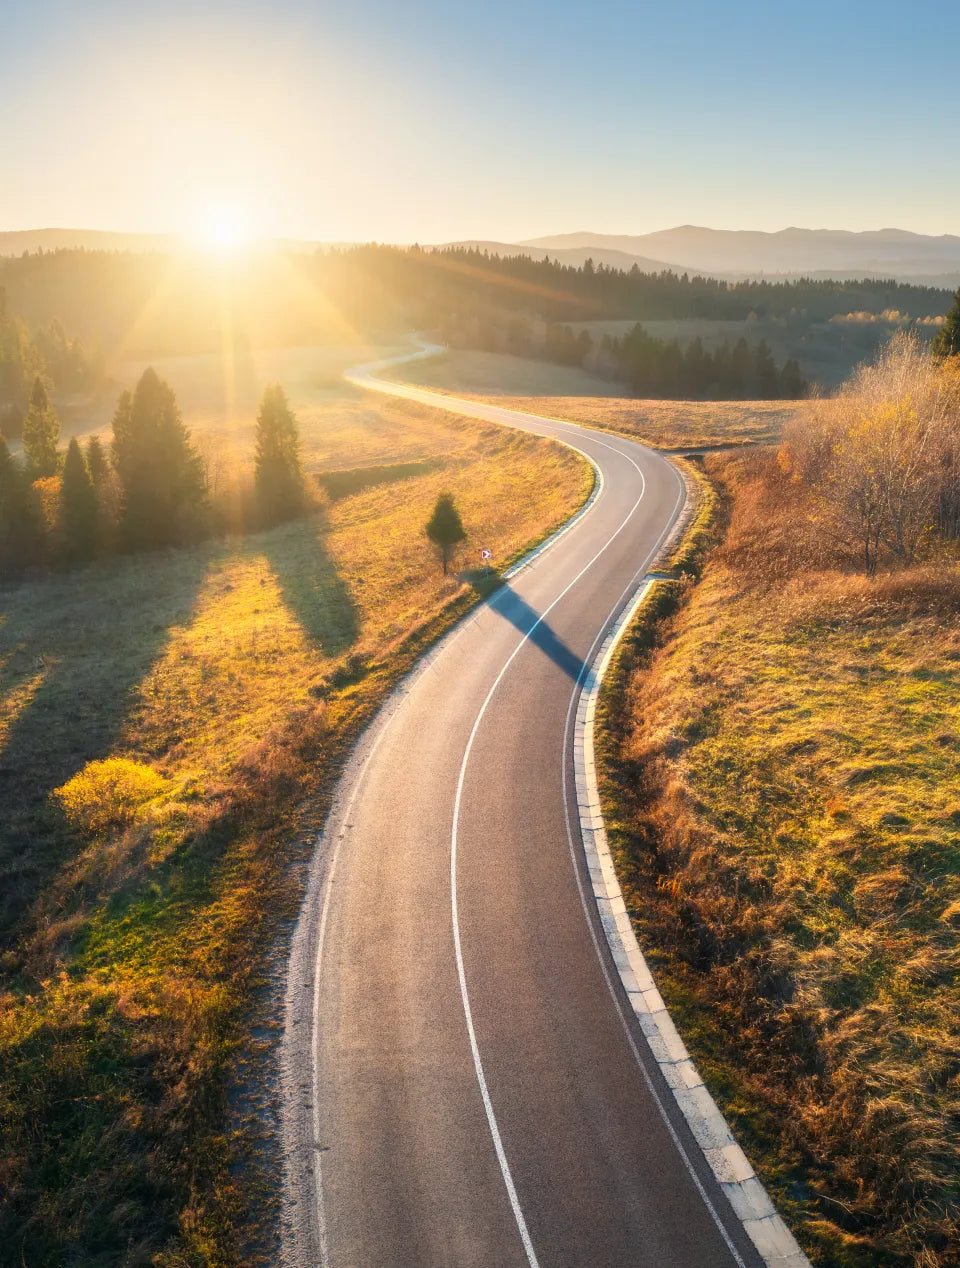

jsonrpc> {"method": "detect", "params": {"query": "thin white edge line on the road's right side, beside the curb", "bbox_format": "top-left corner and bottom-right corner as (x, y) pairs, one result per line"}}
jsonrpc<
(561, 468), (747, 1268)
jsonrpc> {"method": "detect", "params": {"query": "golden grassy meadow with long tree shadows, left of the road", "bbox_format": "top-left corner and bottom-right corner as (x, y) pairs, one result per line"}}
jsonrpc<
(0, 366), (592, 1268)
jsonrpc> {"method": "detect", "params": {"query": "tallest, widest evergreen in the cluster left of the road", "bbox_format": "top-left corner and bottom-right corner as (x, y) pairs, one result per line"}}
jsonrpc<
(112, 366), (207, 549)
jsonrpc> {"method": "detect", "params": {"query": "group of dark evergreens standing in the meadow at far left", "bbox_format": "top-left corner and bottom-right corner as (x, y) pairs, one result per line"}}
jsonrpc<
(0, 369), (305, 579)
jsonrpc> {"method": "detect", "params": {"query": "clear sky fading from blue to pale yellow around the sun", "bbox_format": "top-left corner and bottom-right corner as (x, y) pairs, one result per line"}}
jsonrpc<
(0, 0), (960, 242)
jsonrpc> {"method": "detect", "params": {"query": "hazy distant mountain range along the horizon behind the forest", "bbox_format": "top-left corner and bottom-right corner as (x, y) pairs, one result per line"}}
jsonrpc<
(0, 224), (960, 290)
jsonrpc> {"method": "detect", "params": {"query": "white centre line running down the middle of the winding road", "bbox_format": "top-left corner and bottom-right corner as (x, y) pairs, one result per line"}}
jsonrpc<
(450, 450), (672, 1268)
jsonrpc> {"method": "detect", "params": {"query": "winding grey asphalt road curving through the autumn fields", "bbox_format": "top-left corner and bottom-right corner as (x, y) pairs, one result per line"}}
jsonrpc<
(283, 347), (761, 1268)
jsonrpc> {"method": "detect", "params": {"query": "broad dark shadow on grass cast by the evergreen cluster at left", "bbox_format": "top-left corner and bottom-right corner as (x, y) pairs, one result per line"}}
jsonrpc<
(0, 543), (216, 945)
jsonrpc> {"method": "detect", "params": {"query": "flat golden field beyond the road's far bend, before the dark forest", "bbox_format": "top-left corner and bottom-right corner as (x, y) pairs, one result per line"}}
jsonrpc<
(397, 351), (807, 449)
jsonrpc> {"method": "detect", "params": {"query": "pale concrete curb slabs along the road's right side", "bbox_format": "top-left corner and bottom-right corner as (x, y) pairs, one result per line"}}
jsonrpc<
(573, 570), (810, 1268)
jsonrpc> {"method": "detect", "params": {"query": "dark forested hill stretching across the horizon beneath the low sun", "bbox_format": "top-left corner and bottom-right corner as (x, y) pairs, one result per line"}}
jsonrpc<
(0, 246), (950, 356)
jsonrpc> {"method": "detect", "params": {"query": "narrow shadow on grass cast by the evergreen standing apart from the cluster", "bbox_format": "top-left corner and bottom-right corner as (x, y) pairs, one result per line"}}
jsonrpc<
(251, 515), (360, 657)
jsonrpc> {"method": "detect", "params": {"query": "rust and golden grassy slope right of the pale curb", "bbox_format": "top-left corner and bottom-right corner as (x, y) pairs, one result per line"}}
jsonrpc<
(601, 451), (960, 1268)
